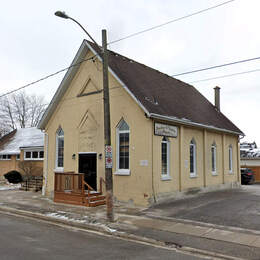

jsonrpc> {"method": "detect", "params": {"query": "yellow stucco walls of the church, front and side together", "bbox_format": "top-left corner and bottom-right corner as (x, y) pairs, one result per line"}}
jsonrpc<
(44, 50), (238, 205)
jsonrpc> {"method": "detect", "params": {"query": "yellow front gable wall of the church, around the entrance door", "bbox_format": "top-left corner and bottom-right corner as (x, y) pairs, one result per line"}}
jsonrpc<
(45, 51), (152, 204)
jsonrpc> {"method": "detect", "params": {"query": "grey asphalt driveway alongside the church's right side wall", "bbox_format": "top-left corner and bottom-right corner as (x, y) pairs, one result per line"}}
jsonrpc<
(146, 184), (260, 231)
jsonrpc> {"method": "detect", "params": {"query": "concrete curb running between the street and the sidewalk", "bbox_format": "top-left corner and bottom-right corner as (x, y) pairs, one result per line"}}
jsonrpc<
(0, 206), (242, 260)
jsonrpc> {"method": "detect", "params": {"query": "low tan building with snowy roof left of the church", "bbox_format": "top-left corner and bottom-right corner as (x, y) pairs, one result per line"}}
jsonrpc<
(0, 127), (44, 178)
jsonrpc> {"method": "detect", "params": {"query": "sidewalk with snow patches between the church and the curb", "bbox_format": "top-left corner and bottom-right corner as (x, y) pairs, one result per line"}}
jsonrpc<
(0, 190), (260, 259)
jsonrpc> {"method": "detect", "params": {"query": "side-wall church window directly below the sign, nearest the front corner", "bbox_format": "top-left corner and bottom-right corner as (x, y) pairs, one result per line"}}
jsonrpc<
(161, 137), (170, 180)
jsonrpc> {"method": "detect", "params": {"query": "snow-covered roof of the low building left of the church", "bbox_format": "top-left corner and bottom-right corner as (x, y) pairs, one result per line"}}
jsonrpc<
(0, 127), (44, 154)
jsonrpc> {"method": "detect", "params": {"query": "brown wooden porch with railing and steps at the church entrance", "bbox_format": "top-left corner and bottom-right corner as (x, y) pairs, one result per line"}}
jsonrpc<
(54, 172), (106, 207)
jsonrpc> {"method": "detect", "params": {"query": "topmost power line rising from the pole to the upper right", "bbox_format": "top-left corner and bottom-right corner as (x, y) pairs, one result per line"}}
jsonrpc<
(108, 0), (235, 45)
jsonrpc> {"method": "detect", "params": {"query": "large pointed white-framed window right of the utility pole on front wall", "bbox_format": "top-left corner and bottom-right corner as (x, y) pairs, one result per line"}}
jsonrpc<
(116, 119), (130, 175)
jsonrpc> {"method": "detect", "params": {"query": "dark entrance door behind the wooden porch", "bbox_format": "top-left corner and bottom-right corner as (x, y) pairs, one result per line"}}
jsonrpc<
(79, 153), (97, 190)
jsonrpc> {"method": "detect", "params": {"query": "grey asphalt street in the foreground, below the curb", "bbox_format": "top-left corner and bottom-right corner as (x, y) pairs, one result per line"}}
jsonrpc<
(0, 214), (201, 260)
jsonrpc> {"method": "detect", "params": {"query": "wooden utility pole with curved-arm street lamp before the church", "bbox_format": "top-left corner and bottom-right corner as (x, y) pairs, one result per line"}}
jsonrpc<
(55, 11), (114, 222)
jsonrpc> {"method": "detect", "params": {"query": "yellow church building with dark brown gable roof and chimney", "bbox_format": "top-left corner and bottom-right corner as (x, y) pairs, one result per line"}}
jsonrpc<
(38, 40), (243, 205)
